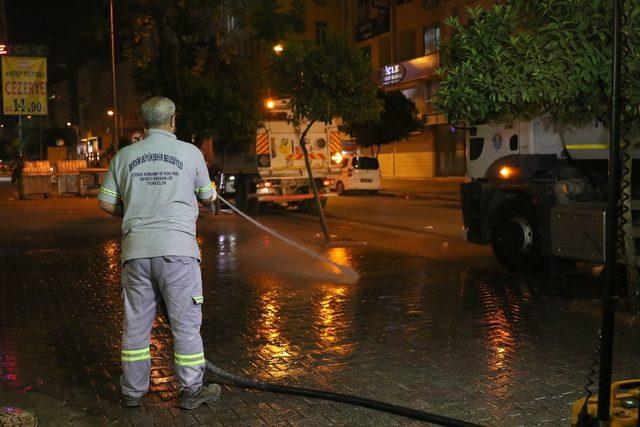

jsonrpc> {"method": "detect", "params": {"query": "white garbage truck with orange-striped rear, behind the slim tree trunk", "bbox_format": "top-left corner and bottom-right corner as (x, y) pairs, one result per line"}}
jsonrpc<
(214, 102), (342, 213)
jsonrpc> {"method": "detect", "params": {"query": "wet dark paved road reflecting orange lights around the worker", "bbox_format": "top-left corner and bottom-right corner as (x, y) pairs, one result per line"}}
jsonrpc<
(0, 191), (640, 426)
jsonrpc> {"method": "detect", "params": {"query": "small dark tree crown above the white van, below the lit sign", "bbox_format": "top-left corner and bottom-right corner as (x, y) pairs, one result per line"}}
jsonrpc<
(345, 91), (421, 155)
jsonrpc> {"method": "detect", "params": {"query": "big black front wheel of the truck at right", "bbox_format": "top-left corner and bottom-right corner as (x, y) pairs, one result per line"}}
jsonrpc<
(491, 197), (544, 273)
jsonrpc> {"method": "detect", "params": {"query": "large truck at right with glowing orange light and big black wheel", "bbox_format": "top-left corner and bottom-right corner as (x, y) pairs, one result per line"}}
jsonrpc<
(461, 118), (640, 273)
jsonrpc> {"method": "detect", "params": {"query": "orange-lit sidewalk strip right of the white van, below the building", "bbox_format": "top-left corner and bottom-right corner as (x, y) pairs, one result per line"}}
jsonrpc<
(378, 177), (468, 201)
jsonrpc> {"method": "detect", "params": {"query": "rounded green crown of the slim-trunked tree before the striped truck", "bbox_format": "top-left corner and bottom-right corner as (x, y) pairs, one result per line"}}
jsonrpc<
(272, 34), (382, 132)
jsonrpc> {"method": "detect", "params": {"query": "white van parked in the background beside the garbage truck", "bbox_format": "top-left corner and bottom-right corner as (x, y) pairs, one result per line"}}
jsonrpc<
(335, 154), (382, 194)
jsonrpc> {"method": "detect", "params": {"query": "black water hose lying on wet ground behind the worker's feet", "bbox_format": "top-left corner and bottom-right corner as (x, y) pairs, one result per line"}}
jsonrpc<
(205, 360), (479, 427)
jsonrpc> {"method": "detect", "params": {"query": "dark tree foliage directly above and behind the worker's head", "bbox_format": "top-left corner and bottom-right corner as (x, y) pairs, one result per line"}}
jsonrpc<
(123, 0), (304, 152)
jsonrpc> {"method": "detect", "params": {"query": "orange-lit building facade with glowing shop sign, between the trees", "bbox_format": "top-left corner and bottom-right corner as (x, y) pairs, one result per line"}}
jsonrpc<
(351, 0), (495, 179)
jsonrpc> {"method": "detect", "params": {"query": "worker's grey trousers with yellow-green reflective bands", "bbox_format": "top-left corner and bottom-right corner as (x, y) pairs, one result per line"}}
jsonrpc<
(120, 256), (205, 397)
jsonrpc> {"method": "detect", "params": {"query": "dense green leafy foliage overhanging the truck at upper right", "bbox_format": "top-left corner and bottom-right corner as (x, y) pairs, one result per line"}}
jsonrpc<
(436, 0), (640, 124)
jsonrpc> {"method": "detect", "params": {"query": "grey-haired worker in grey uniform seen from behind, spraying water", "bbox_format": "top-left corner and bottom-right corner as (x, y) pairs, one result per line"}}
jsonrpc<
(98, 97), (220, 409)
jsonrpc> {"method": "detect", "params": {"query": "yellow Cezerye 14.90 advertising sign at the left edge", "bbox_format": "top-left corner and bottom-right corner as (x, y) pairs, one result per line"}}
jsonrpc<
(2, 56), (47, 116)
